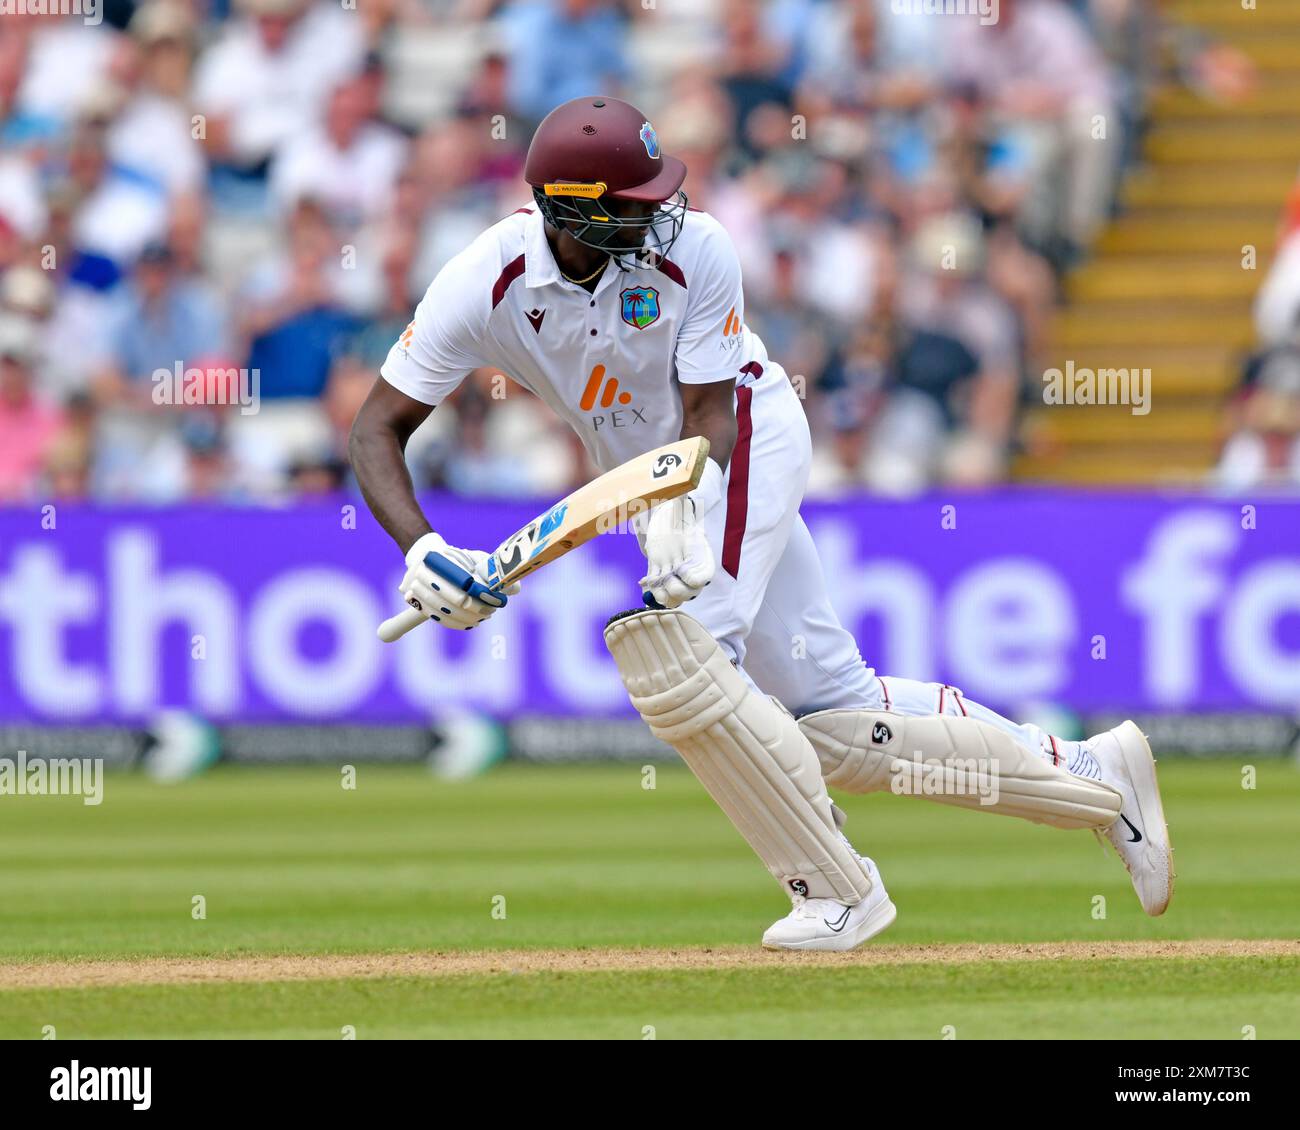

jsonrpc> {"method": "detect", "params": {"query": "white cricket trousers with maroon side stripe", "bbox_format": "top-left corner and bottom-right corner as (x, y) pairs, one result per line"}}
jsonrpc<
(684, 363), (1073, 765)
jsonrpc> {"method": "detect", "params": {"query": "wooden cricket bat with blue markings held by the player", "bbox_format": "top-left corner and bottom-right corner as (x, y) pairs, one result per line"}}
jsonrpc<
(380, 436), (709, 644)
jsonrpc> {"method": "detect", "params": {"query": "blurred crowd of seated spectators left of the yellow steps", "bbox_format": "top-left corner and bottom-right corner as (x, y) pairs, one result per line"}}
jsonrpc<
(0, 0), (1237, 502)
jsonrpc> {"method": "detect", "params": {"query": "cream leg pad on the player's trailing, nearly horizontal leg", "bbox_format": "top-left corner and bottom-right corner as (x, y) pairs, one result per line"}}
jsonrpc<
(800, 710), (1121, 828)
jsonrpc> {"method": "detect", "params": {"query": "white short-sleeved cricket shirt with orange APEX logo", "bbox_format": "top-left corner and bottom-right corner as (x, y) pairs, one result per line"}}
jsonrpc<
(380, 208), (771, 471)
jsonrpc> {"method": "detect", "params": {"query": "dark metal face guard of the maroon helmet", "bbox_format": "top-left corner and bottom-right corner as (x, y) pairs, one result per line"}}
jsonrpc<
(533, 182), (686, 270)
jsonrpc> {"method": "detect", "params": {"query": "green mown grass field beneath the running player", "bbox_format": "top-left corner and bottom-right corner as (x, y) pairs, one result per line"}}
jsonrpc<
(0, 761), (1300, 1039)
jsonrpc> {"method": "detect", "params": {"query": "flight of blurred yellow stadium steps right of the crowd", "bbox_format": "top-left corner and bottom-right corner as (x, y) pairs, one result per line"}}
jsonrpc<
(1013, 0), (1300, 485)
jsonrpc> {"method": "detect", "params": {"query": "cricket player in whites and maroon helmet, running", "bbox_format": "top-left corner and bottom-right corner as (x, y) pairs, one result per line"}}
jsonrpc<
(351, 98), (1173, 949)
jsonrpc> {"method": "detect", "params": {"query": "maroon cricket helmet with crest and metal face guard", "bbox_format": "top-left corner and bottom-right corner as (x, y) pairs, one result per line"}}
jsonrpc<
(524, 96), (686, 256)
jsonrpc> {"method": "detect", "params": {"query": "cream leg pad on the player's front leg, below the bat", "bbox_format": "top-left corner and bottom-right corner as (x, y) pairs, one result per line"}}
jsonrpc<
(605, 610), (871, 904)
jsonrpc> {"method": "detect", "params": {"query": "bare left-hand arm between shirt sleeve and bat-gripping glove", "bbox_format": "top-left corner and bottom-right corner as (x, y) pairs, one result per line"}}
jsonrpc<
(347, 377), (433, 554)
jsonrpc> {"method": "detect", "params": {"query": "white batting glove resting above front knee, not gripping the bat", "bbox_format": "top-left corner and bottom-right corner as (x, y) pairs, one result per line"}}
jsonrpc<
(641, 459), (723, 609)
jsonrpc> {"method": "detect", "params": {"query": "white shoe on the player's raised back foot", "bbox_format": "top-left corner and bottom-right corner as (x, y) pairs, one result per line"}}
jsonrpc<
(1086, 722), (1174, 917)
